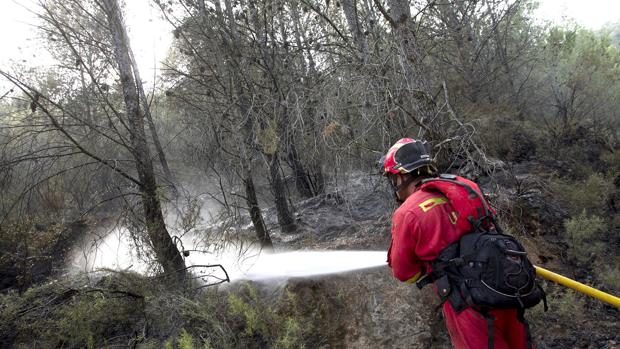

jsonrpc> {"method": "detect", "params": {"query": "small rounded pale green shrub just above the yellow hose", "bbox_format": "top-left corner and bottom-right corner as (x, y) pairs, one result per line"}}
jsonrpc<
(564, 210), (607, 264)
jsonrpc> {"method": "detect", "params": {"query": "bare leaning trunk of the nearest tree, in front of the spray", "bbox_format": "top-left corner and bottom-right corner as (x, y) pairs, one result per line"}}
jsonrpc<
(102, 0), (186, 281)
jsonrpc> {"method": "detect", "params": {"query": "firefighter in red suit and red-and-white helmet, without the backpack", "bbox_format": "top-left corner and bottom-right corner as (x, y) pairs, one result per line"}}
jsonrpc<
(381, 138), (531, 349)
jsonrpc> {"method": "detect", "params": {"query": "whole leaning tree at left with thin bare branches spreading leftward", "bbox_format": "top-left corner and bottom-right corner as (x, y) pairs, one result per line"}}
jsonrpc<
(1, 0), (186, 281)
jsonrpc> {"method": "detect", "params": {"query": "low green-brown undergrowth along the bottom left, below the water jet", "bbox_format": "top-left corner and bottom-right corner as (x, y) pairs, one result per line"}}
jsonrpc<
(0, 273), (312, 349)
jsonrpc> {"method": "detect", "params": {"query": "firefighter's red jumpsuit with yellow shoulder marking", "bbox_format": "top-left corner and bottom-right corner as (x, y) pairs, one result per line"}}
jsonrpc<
(388, 178), (527, 349)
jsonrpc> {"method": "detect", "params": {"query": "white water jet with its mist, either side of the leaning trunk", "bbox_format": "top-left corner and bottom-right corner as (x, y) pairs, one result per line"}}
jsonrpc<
(69, 178), (386, 284)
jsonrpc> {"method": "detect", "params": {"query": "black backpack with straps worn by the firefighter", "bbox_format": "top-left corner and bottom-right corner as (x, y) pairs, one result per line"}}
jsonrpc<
(417, 175), (547, 348)
